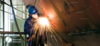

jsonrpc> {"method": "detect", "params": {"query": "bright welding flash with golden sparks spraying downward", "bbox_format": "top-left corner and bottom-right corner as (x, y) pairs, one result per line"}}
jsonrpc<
(31, 17), (62, 44)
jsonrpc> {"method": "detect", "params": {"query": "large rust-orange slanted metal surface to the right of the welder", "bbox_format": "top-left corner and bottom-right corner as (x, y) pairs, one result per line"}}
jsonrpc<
(22, 0), (100, 46)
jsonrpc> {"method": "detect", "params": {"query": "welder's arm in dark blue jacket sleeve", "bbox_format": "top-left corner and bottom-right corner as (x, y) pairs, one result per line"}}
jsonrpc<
(24, 20), (34, 34)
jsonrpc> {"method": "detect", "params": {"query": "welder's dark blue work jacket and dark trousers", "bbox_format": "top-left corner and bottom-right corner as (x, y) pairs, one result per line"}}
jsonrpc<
(24, 16), (47, 46)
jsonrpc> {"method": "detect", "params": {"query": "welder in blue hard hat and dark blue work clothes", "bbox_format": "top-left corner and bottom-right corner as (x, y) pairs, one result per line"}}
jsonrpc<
(24, 6), (47, 46)
